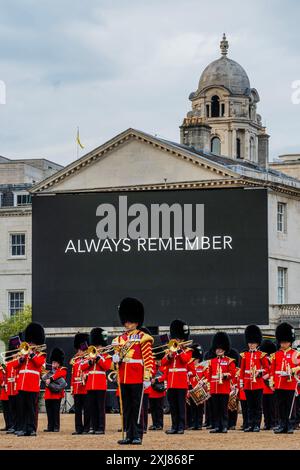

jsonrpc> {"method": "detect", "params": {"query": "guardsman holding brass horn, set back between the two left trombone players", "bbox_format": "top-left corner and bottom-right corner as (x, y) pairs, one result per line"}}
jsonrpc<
(43, 348), (67, 432)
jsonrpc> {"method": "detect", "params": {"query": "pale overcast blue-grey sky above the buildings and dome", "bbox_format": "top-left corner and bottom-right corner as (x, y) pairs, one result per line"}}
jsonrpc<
(0, 0), (300, 164)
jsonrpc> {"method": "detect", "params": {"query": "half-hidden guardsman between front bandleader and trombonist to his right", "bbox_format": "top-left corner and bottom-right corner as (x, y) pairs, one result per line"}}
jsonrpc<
(149, 351), (167, 431)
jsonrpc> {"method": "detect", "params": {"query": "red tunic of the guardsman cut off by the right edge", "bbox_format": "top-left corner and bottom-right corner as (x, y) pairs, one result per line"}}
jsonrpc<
(270, 348), (300, 390)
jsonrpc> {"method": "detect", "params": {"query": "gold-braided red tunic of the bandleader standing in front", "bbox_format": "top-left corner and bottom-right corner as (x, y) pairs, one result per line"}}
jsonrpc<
(112, 330), (154, 384)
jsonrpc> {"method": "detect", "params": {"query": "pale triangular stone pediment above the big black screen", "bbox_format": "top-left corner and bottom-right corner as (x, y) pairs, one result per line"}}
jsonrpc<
(32, 129), (238, 193)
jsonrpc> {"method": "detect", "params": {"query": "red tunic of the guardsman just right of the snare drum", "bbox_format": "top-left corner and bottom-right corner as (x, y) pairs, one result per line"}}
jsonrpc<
(207, 356), (236, 395)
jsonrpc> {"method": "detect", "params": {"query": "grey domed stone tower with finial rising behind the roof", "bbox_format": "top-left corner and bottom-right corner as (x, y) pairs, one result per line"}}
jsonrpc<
(180, 34), (269, 166)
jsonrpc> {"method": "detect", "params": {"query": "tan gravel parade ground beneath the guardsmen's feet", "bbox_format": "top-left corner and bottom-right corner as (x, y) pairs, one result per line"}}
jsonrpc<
(0, 414), (300, 450)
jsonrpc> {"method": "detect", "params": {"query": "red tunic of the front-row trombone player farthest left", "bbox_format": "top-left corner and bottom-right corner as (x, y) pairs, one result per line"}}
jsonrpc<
(12, 352), (46, 392)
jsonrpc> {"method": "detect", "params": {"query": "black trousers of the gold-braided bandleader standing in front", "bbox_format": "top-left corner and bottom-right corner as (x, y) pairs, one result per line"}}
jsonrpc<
(121, 383), (143, 441)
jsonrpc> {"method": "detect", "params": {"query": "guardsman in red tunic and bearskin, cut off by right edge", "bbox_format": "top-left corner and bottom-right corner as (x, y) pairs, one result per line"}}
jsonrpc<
(270, 323), (300, 434)
